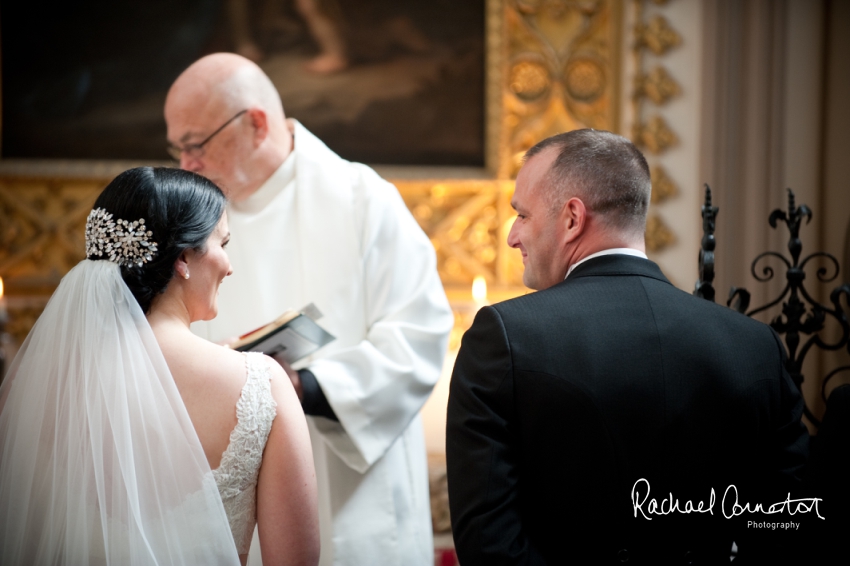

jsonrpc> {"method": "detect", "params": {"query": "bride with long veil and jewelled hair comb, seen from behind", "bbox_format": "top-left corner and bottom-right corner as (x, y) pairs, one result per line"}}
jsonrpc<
(0, 167), (319, 566)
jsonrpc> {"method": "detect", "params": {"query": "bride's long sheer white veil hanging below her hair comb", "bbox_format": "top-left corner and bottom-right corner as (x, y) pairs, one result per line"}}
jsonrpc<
(0, 260), (239, 566)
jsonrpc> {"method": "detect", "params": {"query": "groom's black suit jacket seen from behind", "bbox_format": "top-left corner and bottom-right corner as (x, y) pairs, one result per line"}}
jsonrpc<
(446, 255), (808, 566)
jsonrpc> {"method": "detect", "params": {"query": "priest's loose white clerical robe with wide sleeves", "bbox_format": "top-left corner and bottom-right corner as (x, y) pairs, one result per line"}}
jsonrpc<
(193, 122), (453, 566)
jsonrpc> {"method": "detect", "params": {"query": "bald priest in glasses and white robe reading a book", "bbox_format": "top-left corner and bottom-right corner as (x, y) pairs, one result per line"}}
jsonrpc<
(165, 53), (453, 565)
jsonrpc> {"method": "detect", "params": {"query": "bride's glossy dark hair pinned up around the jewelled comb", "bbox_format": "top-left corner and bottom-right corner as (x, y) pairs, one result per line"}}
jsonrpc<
(89, 167), (227, 314)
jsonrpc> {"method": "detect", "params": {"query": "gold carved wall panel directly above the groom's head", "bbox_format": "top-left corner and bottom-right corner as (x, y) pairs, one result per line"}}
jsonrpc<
(488, 0), (620, 179)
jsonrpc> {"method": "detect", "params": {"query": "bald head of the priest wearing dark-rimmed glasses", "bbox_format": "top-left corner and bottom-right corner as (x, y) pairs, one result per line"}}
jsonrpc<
(165, 53), (292, 201)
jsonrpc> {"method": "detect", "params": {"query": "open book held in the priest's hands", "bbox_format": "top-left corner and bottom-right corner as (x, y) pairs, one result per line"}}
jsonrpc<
(235, 303), (336, 364)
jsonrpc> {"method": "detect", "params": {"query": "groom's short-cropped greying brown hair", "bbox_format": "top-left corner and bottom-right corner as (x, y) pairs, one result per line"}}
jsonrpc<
(525, 129), (652, 239)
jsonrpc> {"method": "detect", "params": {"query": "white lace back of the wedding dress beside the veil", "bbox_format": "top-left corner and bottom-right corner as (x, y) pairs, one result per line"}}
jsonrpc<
(213, 352), (277, 554)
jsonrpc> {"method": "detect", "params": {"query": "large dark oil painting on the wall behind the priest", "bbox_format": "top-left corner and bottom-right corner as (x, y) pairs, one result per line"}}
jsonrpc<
(0, 0), (484, 166)
